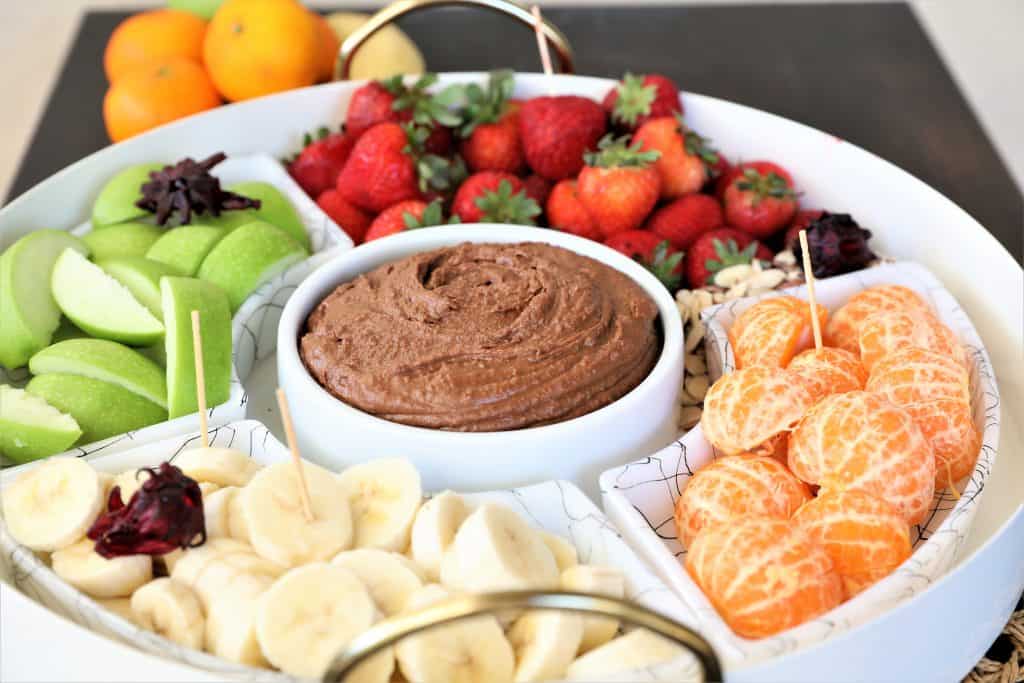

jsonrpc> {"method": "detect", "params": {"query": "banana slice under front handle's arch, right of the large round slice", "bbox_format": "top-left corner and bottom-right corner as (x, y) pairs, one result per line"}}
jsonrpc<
(508, 609), (583, 683)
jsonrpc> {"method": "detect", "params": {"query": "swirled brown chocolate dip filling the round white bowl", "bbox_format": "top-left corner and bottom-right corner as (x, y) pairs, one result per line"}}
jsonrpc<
(300, 243), (660, 431)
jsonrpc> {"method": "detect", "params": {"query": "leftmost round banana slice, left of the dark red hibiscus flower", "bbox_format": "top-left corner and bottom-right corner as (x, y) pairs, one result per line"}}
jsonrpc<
(0, 458), (106, 552)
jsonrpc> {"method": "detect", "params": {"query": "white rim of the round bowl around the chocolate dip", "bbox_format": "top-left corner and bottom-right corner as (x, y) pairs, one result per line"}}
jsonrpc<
(276, 223), (684, 445)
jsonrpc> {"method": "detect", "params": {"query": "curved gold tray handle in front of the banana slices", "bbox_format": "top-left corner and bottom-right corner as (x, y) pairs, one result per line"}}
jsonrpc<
(323, 591), (722, 683)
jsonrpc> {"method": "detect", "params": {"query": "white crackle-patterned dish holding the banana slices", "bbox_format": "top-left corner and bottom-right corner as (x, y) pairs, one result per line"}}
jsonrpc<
(0, 420), (700, 681)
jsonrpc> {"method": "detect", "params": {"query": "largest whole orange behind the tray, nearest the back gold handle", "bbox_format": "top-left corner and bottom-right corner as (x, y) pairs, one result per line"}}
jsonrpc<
(203, 0), (321, 100)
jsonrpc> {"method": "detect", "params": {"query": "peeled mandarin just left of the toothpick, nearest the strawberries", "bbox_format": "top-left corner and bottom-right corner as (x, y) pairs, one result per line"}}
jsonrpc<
(728, 296), (828, 368)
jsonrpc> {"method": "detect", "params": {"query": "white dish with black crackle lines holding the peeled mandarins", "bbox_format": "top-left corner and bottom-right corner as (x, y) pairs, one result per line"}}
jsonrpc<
(600, 263), (999, 667)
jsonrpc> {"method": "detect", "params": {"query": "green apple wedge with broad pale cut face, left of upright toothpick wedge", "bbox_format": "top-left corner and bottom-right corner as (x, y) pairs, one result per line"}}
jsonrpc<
(50, 249), (164, 346)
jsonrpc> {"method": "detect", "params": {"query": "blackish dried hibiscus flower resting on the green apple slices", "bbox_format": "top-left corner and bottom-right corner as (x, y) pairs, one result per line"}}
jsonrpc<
(135, 152), (260, 225)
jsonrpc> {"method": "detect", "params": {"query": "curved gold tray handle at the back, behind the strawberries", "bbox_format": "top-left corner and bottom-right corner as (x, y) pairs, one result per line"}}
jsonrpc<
(334, 0), (572, 81)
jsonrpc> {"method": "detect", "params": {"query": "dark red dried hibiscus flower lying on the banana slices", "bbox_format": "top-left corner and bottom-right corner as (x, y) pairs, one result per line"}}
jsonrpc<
(87, 463), (206, 558)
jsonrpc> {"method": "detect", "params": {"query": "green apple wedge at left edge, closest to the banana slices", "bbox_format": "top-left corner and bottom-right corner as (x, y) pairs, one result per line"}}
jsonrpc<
(0, 384), (82, 463)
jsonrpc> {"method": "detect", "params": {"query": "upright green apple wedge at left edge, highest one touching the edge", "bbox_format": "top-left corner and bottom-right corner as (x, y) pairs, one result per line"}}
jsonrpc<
(0, 229), (89, 369)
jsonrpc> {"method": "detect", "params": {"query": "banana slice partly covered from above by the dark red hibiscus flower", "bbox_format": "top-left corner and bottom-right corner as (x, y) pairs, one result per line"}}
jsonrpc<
(52, 539), (153, 598)
